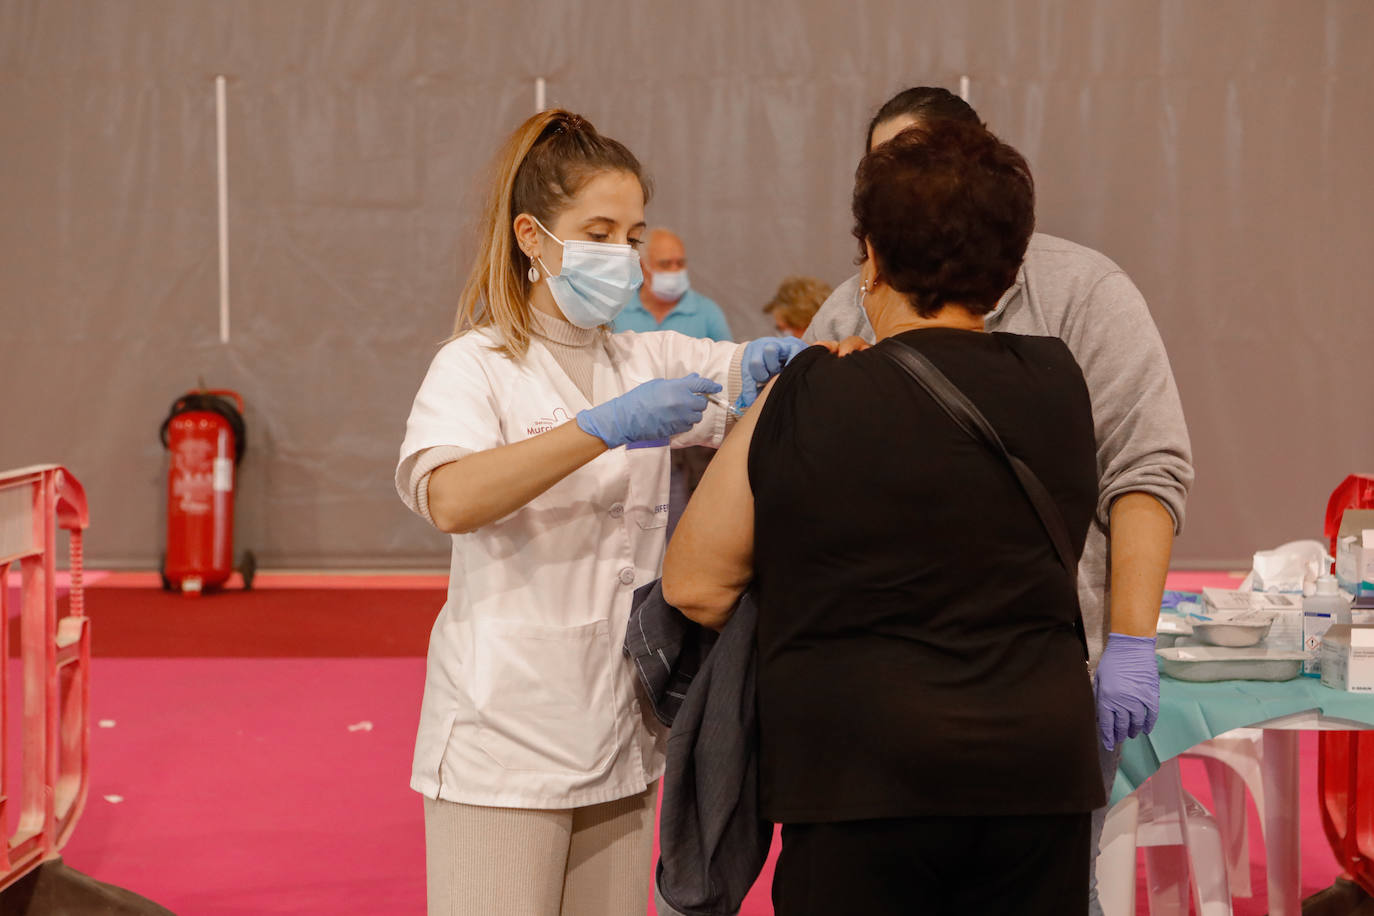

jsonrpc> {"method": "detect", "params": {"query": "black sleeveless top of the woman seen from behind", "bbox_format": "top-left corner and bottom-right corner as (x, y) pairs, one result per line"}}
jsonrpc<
(749, 328), (1106, 823)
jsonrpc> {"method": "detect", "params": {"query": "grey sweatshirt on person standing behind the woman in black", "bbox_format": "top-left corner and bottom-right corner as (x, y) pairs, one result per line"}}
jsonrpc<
(804, 233), (1193, 666)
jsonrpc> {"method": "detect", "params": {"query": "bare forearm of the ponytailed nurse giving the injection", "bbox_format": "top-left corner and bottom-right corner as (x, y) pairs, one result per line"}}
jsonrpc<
(429, 423), (606, 534)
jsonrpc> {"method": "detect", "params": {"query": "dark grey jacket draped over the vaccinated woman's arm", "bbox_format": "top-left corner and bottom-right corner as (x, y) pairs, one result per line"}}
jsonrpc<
(625, 582), (772, 916)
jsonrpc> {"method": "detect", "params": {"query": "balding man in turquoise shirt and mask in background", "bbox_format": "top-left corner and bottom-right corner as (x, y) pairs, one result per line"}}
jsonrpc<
(613, 229), (731, 341)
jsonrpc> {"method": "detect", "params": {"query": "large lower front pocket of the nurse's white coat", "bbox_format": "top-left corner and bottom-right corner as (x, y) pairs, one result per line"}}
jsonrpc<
(473, 619), (617, 775)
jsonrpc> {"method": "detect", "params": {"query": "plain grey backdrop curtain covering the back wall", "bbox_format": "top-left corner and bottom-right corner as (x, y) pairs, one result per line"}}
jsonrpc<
(0, 0), (1374, 566)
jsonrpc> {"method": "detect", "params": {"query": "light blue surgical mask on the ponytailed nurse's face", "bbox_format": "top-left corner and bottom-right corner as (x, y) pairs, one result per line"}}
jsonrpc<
(534, 220), (644, 328)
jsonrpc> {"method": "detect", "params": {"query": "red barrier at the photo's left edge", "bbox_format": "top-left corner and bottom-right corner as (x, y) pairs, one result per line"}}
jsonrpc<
(0, 464), (91, 891)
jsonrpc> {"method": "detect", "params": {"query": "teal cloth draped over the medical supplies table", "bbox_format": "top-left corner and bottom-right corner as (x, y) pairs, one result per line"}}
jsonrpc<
(1112, 676), (1374, 805)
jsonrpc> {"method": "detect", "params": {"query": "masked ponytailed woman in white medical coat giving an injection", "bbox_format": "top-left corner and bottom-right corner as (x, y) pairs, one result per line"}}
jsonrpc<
(396, 111), (800, 916)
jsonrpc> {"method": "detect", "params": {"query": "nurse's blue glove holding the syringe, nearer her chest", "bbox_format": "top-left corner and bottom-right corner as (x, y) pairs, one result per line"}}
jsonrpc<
(577, 372), (720, 449)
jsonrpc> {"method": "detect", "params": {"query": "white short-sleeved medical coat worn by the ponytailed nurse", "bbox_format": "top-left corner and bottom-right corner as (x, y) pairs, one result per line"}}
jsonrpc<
(397, 328), (739, 809)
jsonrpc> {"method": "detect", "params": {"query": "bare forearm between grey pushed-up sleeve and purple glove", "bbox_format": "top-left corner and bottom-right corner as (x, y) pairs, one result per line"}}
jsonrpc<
(1109, 493), (1173, 637)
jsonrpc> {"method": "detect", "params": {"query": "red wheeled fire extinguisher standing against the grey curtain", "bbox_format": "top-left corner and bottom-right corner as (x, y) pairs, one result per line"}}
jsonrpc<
(161, 389), (257, 595)
